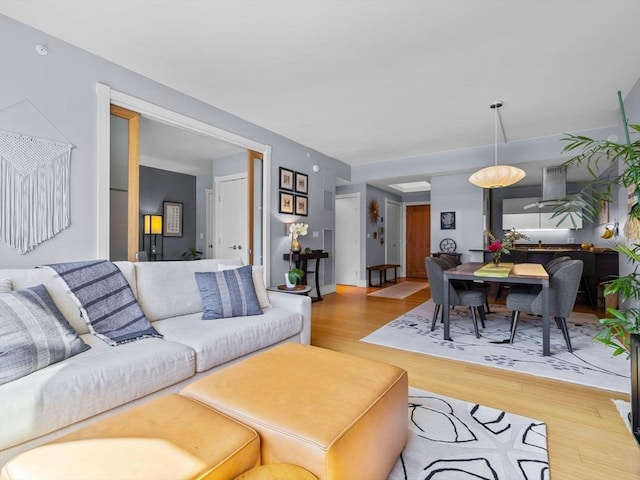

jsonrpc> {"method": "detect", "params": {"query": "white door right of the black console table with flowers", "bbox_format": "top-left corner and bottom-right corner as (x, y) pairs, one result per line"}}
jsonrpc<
(335, 193), (361, 285)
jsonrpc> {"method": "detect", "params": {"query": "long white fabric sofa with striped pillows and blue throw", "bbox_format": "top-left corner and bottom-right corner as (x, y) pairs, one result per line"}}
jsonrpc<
(0, 259), (311, 465)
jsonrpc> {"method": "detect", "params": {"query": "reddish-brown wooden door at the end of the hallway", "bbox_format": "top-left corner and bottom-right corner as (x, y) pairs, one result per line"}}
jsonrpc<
(406, 205), (431, 278)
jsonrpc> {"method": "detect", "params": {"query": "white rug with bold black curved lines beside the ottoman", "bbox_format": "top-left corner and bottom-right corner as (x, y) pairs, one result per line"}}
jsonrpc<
(389, 388), (550, 480)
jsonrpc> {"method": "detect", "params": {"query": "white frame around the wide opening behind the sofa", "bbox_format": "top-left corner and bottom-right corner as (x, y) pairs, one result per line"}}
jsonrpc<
(96, 83), (271, 279)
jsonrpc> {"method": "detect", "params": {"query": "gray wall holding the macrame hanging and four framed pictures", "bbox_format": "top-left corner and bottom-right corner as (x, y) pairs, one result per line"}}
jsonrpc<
(0, 15), (351, 283)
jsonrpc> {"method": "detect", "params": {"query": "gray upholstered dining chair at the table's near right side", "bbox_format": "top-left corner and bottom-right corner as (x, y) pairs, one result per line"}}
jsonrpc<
(507, 260), (582, 352)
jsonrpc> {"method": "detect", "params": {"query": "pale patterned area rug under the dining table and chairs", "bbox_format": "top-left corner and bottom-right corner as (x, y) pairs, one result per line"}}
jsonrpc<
(362, 300), (630, 393)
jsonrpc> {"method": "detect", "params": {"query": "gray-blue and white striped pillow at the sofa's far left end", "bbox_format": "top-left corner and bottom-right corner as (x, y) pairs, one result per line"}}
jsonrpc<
(0, 285), (90, 385)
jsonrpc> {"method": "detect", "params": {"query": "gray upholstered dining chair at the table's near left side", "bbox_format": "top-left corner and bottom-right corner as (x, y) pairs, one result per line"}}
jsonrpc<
(424, 257), (487, 338)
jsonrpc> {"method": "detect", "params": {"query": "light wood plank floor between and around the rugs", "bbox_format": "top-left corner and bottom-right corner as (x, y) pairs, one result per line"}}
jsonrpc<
(311, 278), (640, 480)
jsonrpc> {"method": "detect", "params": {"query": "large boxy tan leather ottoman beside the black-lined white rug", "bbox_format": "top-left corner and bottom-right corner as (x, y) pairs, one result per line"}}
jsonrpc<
(181, 343), (408, 480)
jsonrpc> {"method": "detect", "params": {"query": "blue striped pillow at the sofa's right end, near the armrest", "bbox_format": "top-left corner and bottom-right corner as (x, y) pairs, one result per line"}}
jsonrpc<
(195, 265), (262, 320)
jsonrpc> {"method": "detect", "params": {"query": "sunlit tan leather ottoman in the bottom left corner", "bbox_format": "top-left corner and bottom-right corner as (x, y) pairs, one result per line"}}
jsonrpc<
(0, 394), (260, 480)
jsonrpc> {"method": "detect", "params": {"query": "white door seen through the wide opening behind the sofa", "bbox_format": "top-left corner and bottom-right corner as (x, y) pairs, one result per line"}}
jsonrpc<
(214, 173), (249, 264)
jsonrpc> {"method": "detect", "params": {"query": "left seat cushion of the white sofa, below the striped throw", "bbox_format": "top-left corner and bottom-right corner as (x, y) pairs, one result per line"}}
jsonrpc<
(0, 334), (195, 449)
